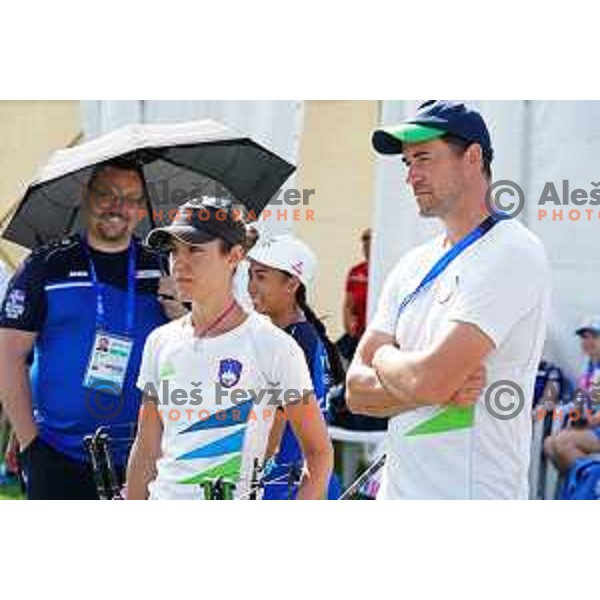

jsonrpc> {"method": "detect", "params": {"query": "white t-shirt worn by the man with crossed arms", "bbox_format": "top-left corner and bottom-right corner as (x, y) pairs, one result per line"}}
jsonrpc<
(369, 220), (550, 499)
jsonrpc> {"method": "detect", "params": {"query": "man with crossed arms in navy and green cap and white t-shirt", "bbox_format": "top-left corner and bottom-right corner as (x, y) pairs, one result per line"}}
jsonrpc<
(347, 100), (549, 499)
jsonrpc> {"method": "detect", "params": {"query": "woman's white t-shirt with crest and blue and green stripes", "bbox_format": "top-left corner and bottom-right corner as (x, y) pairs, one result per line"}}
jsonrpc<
(137, 313), (312, 499)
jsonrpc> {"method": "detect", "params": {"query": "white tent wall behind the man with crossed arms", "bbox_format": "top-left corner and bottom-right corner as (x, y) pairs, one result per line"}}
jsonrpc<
(369, 101), (600, 376)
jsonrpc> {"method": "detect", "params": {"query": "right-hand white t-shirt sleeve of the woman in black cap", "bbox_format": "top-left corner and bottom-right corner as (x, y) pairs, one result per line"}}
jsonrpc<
(265, 331), (313, 404)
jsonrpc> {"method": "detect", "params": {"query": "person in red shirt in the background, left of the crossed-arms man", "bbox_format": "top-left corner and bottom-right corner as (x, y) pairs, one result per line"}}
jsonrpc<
(339, 229), (371, 361)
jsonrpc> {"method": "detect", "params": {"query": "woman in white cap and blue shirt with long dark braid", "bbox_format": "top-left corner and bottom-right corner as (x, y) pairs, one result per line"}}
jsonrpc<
(248, 235), (344, 500)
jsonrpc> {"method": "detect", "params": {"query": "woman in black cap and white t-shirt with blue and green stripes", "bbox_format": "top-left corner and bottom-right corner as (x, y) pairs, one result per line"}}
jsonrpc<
(127, 199), (333, 499)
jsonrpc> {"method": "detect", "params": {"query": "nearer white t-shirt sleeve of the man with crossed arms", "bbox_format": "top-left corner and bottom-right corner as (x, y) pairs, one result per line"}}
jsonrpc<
(450, 239), (550, 348)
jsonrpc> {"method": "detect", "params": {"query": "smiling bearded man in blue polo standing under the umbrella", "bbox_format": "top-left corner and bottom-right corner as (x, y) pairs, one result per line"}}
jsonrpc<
(0, 159), (183, 499)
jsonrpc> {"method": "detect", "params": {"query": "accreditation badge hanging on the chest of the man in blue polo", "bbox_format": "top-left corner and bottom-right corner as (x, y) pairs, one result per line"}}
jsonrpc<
(83, 331), (133, 395)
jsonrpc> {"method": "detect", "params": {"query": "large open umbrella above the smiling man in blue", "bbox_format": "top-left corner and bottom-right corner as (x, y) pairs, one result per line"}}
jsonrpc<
(2, 120), (295, 248)
